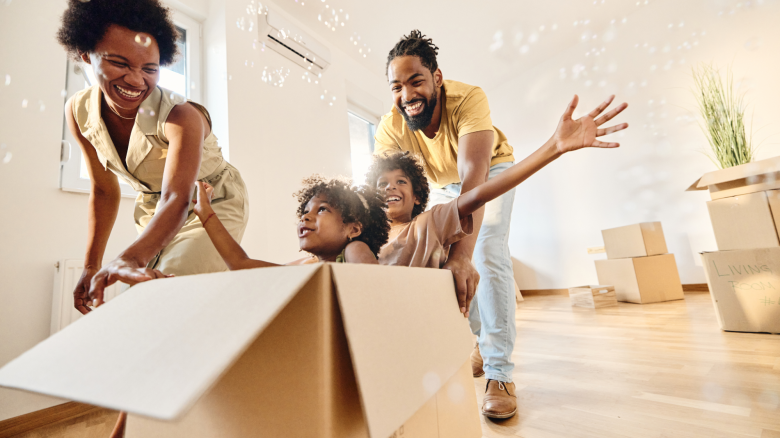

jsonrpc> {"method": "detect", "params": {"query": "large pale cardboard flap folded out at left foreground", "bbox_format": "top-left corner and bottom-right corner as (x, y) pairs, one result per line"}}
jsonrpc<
(0, 265), (323, 420)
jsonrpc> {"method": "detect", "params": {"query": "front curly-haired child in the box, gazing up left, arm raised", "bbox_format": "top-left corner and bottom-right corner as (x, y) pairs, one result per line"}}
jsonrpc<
(194, 175), (390, 271)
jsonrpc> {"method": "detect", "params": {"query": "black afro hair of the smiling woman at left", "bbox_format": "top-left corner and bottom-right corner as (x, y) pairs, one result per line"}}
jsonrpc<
(57, 0), (179, 65)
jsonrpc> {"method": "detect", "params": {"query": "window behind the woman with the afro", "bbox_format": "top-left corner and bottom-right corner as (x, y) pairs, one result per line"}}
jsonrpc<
(60, 12), (201, 198)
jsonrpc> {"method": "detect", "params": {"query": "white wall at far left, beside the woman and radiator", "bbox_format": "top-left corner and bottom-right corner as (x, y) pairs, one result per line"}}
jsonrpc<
(0, 0), (142, 420)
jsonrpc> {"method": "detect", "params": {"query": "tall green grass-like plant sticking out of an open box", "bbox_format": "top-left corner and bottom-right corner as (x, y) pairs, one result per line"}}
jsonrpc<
(693, 64), (755, 169)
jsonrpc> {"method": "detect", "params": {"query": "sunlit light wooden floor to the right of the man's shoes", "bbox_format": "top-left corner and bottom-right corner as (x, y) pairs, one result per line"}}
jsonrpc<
(474, 293), (780, 438)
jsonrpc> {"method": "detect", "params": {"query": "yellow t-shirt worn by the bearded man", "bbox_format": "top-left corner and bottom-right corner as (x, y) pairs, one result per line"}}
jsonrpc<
(374, 80), (515, 188)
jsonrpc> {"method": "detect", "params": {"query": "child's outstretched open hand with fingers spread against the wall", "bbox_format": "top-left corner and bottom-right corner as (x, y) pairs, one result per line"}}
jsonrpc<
(552, 94), (628, 154)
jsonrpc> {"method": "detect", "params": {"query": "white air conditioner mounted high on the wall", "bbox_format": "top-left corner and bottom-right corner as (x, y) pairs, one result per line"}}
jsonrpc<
(257, 9), (330, 74)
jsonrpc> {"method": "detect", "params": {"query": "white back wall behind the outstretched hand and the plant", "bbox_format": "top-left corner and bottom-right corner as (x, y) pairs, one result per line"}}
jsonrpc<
(486, 0), (780, 289)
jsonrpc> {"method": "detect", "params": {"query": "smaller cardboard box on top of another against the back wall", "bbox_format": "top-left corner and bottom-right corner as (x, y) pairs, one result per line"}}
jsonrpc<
(601, 222), (668, 259)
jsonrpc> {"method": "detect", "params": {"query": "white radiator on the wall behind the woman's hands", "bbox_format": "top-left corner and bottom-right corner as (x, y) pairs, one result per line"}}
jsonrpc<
(50, 259), (124, 335)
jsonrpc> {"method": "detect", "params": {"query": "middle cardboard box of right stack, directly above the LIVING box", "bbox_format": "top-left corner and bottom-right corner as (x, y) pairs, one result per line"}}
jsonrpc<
(707, 190), (780, 251)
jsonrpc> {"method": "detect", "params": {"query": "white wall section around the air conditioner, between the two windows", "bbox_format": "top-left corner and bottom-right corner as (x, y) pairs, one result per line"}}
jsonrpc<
(218, 0), (389, 262)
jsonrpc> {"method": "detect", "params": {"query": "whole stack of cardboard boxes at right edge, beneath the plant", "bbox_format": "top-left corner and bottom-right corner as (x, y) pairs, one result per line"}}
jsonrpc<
(688, 157), (780, 333)
